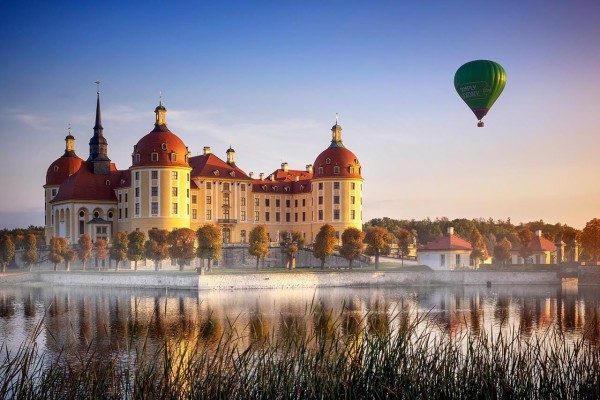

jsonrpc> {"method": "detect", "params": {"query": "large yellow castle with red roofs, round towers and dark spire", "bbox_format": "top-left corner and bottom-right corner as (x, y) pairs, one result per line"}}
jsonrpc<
(44, 93), (363, 243)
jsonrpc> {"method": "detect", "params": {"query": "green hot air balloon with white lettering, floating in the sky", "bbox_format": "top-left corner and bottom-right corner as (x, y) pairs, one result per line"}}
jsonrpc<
(454, 60), (506, 127)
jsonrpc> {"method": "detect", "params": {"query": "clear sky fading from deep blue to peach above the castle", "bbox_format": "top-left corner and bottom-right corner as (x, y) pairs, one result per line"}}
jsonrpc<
(0, 0), (600, 229)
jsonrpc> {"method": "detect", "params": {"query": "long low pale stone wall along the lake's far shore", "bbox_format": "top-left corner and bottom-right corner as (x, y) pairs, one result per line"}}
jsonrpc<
(0, 271), (561, 291)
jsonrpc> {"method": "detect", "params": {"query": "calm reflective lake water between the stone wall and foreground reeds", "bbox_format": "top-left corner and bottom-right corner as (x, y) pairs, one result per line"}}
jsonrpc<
(0, 286), (600, 359)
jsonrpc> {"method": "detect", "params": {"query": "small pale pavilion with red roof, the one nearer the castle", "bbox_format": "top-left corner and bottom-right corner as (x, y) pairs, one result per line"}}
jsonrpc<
(417, 227), (474, 271)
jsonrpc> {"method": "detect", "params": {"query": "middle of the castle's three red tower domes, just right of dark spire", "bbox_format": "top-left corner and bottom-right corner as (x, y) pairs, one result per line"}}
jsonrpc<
(132, 125), (190, 167)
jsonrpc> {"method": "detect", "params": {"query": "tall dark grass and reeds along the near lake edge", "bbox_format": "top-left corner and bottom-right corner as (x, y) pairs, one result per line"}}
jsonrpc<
(0, 305), (600, 399)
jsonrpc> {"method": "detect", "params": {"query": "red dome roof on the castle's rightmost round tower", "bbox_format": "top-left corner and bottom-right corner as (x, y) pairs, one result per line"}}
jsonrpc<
(313, 142), (362, 179)
